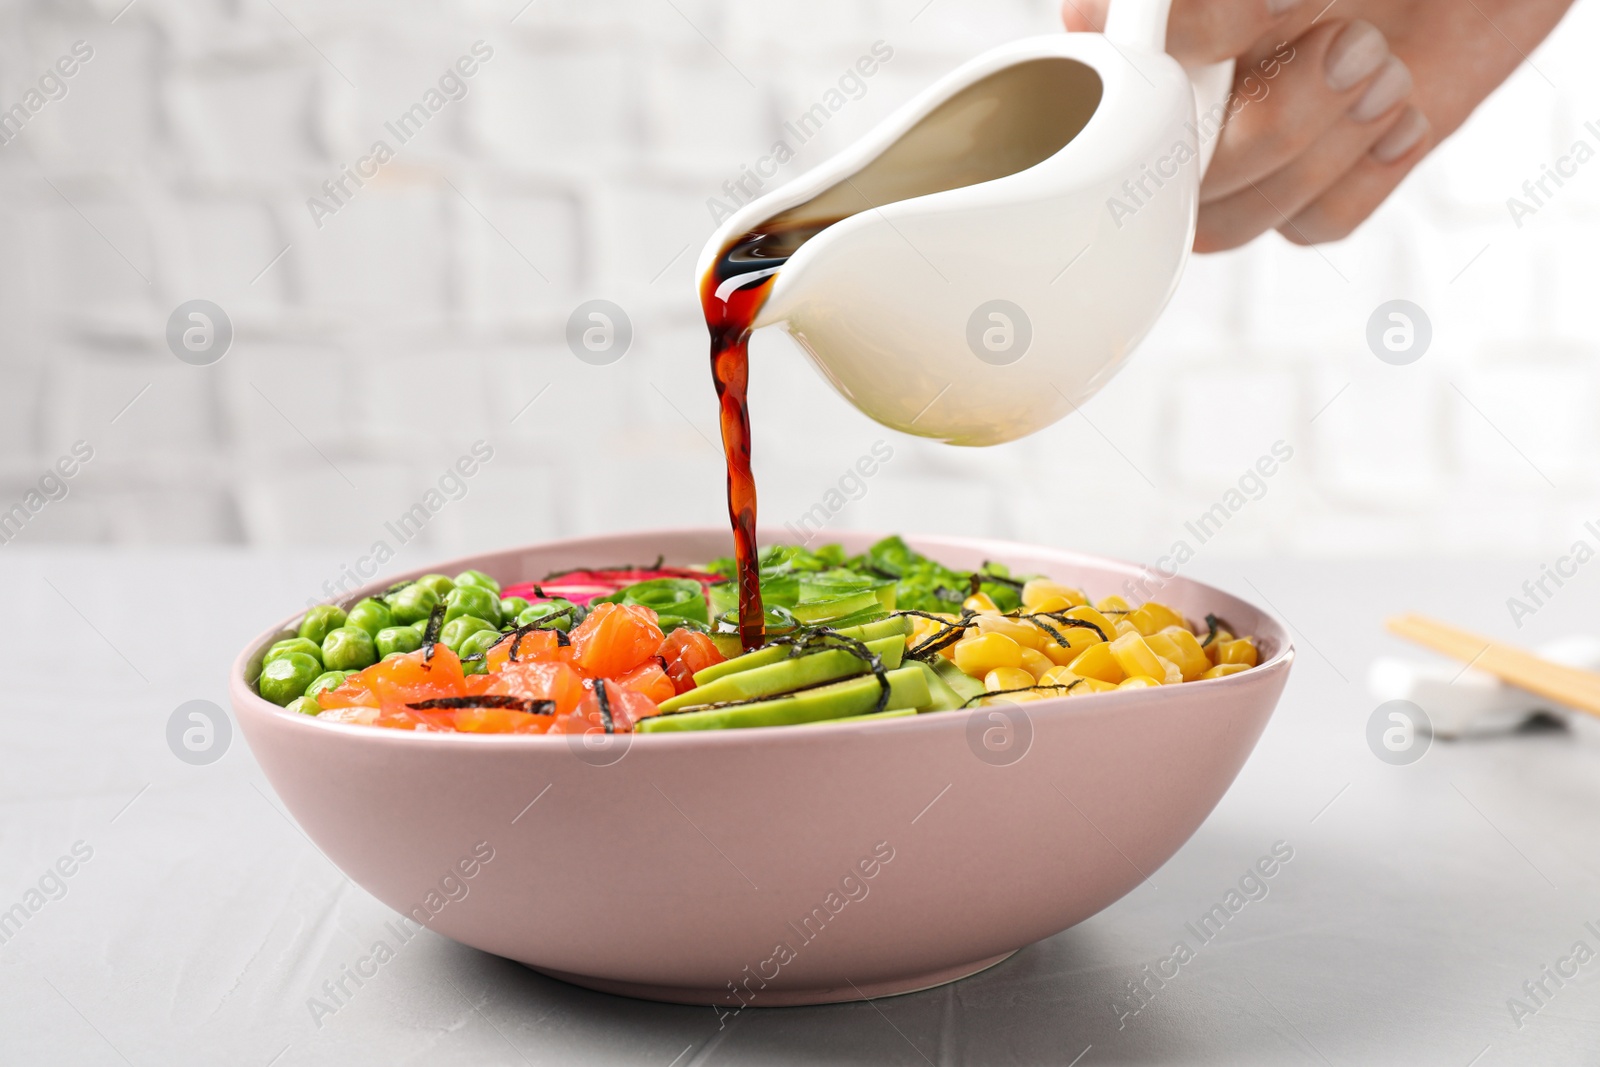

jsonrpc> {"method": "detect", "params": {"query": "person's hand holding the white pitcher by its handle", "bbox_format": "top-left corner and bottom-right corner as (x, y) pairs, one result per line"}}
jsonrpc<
(1062, 0), (1571, 251)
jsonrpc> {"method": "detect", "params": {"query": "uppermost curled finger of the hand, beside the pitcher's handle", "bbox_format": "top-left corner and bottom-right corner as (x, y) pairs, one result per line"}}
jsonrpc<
(1200, 21), (1411, 203)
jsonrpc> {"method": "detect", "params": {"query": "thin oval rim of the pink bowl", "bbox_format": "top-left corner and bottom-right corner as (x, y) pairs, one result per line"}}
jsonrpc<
(229, 526), (1296, 750)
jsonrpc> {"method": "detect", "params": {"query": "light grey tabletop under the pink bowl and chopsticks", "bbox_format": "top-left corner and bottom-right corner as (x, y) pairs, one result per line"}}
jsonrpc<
(0, 545), (1600, 1067)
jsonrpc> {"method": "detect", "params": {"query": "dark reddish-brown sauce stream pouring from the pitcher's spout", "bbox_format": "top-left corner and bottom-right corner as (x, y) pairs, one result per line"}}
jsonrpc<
(701, 219), (838, 651)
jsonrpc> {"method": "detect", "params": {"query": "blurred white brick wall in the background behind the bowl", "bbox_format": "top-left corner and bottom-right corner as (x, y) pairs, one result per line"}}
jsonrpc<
(0, 0), (1600, 563)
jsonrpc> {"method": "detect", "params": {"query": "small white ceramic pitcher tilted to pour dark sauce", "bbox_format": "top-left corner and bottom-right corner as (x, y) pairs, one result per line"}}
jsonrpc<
(698, 0), (1234, 445)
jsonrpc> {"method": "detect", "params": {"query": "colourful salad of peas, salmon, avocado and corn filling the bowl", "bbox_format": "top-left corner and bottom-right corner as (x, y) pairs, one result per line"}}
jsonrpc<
(248, 536), (1259, 734)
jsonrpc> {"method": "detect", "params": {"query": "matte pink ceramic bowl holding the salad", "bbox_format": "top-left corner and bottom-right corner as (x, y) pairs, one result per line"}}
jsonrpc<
(232, 530), (1294, 1011)
